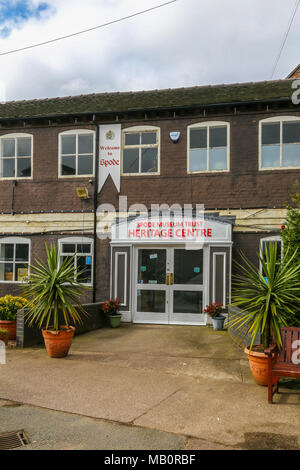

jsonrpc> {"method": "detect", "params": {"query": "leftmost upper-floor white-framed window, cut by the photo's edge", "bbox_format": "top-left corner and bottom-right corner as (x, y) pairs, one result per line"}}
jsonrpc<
(0, 133), (33, 179)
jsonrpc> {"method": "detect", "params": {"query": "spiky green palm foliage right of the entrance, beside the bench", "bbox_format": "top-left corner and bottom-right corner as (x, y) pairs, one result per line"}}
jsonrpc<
(229, 243), (300, 350)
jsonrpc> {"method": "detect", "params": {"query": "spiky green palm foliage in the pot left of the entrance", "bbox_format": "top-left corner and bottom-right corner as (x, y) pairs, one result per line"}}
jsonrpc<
(22, 243), (88, 331)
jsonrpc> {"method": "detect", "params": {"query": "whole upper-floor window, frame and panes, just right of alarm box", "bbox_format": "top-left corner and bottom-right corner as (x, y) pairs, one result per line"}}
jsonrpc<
(187, 121), (230, 173)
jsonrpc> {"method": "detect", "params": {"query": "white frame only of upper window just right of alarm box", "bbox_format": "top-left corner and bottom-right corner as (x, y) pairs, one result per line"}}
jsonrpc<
(187, 121), (230, 175)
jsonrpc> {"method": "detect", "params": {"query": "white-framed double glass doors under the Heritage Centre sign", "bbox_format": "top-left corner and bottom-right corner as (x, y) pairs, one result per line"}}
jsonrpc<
(134, 247), (206, 325)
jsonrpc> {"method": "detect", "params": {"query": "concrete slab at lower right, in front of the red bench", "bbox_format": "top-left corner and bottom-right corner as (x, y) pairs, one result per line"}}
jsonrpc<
(134, 379), (300, 448)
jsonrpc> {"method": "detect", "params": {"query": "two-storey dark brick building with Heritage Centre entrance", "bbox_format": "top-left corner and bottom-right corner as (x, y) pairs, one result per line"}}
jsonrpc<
(0, 67), (300, 324)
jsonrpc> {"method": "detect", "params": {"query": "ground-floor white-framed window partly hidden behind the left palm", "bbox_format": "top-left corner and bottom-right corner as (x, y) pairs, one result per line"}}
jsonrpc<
(58, 237), (93, 286)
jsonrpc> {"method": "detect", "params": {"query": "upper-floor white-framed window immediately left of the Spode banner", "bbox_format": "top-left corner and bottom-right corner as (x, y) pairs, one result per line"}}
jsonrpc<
(58, 129), (96, 178)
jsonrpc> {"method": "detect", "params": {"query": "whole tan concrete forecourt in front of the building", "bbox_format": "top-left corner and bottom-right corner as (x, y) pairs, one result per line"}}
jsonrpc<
(0, 325), (300, 449)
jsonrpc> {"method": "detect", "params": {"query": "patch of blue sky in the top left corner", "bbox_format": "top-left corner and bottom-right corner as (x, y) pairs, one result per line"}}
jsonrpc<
(0, 0), (52, 38)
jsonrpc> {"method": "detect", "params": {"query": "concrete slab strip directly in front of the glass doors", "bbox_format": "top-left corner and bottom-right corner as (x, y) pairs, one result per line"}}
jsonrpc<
(72, 323), (243, 359)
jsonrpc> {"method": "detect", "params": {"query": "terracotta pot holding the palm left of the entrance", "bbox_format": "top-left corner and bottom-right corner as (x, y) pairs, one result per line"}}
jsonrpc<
(42, 326), (75, 358)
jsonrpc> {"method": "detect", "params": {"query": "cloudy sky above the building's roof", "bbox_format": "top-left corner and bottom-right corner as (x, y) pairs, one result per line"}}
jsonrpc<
(0, 0), (300, 101)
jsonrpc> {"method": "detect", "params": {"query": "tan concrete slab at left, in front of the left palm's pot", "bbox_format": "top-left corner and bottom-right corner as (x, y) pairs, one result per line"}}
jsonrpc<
(0, 350), (188, 423)
